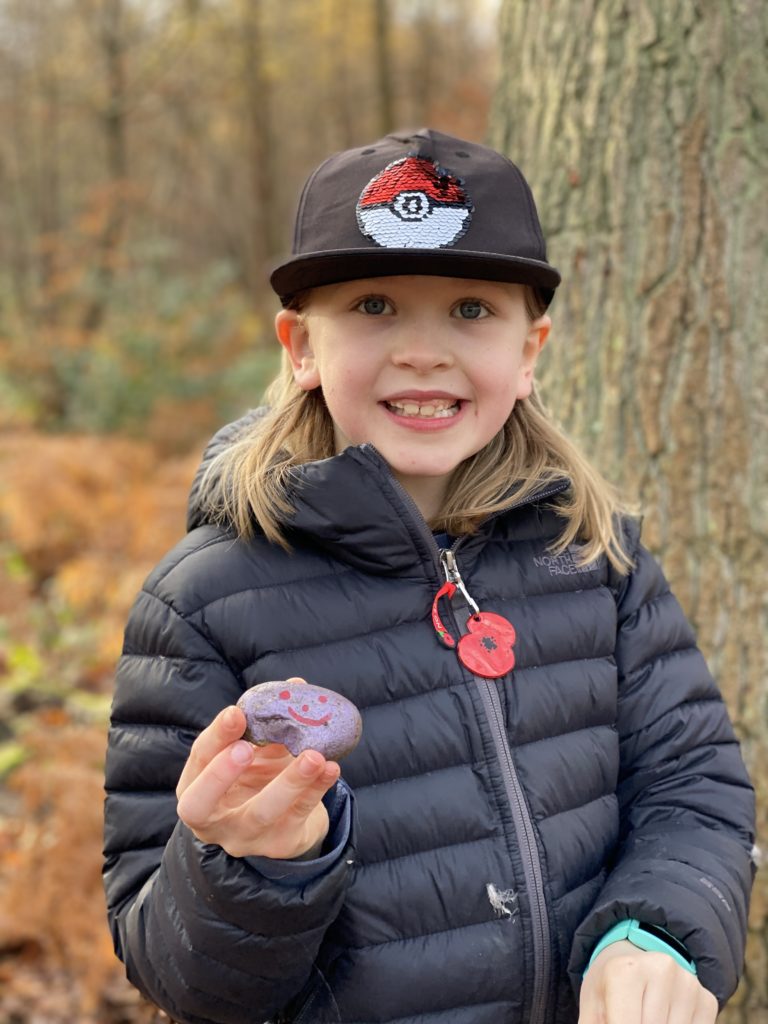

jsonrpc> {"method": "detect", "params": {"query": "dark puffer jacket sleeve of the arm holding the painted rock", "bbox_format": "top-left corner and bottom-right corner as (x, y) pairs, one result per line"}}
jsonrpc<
(103, 577), (353, 1024)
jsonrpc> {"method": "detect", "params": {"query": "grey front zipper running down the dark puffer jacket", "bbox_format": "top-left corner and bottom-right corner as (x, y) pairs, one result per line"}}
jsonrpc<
(440, 544), (552, 1024)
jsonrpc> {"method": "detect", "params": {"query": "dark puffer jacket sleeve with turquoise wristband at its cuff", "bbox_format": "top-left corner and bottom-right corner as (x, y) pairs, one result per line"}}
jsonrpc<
(569, 524), (755, 1006)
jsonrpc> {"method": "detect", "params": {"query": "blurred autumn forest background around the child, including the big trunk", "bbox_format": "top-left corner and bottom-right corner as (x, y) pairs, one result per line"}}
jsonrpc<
(0, 0), (768, 1024)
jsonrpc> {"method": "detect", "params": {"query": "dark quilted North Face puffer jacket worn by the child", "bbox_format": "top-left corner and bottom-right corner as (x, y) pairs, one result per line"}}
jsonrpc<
(104, 413), (753, 1024)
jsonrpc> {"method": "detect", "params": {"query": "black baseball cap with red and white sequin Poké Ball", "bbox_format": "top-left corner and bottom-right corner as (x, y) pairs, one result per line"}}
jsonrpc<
(269, 128), (560, 305)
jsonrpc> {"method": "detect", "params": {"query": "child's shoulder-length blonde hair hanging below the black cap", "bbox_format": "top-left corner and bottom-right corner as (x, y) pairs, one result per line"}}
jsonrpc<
(201, 289), (635, 574)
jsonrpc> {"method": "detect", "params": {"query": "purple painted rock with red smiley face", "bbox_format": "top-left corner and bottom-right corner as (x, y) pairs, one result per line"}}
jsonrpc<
(238, 679), (362, 761)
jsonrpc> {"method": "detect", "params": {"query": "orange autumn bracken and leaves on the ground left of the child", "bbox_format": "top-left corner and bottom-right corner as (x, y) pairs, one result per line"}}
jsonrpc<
(0, 431), (207, 1024)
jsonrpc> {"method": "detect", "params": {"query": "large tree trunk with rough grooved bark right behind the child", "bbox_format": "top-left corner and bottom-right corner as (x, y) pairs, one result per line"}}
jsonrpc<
(490, 0), (768, 1024)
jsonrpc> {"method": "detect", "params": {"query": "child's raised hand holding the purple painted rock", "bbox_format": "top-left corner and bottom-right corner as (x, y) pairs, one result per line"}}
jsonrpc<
(176, 680), (340, 859)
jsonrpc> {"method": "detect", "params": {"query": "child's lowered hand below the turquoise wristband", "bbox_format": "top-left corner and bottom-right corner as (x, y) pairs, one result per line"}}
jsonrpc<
(579, 941), (718, 1024)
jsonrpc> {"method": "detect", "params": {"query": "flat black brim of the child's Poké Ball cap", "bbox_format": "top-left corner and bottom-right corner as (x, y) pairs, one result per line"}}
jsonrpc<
(269, 248), (560, 305)
